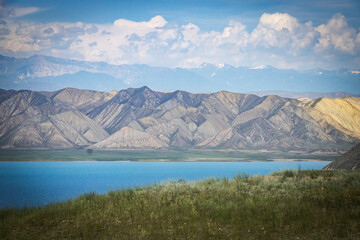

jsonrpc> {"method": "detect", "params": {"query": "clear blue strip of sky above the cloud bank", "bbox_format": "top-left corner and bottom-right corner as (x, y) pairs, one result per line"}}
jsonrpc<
(7, 0), (360, 30)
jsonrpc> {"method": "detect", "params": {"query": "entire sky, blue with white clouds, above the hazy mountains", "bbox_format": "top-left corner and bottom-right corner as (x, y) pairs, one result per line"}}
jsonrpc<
(0, 0), (360, 70)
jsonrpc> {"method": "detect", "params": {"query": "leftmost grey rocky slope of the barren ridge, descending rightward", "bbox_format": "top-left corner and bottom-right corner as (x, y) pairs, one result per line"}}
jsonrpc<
(0, 90), (109, 148)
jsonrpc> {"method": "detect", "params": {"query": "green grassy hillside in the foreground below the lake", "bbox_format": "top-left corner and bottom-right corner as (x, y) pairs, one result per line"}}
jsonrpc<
(0, 170), (360, 239)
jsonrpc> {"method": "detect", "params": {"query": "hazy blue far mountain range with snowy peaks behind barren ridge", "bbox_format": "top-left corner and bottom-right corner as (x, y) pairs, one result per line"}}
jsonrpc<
(0, 55), (360, 94)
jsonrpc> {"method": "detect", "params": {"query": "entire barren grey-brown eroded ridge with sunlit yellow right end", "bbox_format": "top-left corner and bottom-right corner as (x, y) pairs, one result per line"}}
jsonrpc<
(0, 87), (360, 151)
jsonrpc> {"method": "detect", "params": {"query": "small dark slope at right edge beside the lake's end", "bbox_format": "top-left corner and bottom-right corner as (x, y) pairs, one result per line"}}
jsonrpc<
(324, 144), (360, 170)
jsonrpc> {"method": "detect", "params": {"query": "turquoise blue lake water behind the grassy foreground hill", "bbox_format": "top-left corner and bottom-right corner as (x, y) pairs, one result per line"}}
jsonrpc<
(0, 161), (329, 208)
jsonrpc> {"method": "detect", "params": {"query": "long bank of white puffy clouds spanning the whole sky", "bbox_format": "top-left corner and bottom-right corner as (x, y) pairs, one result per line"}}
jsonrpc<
(0, 9), (360, 68)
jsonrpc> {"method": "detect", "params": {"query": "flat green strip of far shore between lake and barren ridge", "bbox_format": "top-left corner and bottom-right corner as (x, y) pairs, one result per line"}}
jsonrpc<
(0, 149), (340, 162)
